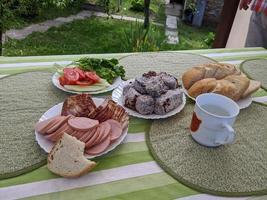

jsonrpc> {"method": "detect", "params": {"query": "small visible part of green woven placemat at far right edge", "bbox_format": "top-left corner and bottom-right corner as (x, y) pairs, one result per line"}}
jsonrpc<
(240, 59), (267, 90)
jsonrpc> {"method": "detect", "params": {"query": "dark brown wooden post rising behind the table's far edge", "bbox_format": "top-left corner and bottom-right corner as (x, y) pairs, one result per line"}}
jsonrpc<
(213, 0), (239, 48)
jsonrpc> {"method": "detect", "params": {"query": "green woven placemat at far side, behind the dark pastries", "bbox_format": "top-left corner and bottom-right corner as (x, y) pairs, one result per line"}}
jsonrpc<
(120, 52), (216, 79)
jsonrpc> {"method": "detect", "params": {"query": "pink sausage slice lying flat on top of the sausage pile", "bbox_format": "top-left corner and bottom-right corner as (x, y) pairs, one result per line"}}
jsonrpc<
(68, 117), (99, 131)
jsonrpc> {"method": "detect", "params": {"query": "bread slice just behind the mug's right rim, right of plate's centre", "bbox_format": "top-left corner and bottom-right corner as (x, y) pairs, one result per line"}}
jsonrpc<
(224, 75), (249, 101)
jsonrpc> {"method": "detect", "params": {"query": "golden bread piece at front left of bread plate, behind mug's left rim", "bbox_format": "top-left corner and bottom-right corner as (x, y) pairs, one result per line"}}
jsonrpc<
(188, 78), (217, 98)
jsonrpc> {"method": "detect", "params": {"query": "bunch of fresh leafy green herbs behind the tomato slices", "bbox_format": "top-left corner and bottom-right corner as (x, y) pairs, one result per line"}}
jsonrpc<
(74, 57), (125, 84)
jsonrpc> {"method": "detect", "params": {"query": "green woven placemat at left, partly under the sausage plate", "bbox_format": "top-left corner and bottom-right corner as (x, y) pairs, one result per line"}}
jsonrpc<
(0, 72), (69, 179)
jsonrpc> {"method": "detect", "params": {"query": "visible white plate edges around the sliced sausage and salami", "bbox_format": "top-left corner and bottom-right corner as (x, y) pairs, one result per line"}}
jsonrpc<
(35, 98), (128, 159)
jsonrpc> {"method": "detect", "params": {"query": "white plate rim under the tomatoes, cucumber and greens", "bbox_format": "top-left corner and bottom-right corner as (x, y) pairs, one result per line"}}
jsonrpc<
(52, 72), (122, 94)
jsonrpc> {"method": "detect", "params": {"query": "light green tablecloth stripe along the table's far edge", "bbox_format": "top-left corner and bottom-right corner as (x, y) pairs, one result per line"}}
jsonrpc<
(0, 47), (264, 64)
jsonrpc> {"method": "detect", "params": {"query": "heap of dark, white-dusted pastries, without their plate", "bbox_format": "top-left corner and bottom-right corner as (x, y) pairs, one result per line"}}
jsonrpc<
(123, 71), (183, 115)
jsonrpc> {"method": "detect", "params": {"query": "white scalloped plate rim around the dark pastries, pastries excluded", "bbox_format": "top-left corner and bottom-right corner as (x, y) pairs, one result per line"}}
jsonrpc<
(112, 79), (186, 119)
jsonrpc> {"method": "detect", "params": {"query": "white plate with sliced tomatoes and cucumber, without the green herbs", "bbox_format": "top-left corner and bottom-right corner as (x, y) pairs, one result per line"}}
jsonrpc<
(52, 67), (121, 94)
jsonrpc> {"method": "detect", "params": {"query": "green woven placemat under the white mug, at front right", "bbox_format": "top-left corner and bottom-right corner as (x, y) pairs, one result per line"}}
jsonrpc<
(147, 103), (267, 196)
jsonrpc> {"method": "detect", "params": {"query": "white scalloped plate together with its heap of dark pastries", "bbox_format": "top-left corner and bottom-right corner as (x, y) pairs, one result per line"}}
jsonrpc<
(112, 71), (186, 119)
